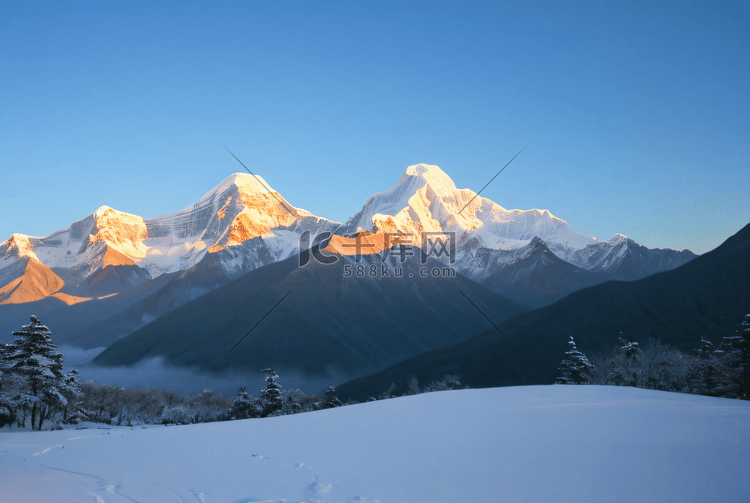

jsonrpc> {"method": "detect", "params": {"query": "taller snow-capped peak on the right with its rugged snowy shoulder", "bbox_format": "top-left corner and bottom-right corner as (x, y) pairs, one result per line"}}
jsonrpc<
(337, 164), (696, 305)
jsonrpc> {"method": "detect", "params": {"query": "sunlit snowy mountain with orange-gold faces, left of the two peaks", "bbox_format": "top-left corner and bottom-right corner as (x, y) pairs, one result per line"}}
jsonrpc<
(0, 173), (339, 304)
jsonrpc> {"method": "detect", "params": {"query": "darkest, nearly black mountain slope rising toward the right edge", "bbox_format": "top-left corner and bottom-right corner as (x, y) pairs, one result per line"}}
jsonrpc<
(338, 225), (750, 400)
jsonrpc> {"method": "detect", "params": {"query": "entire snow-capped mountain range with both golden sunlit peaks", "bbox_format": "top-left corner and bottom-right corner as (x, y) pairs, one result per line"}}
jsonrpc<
(0, 164), (695, 347)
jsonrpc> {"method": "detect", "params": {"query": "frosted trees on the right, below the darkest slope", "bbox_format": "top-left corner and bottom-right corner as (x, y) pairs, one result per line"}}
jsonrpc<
(556, 314), (750, 400)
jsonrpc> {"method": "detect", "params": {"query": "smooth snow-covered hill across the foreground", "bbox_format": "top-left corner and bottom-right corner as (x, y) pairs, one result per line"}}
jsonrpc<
(0, 386), (750, 503)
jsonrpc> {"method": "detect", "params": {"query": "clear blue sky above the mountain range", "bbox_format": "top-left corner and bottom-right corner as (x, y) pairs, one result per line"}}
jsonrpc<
(0, 0), (750, 253)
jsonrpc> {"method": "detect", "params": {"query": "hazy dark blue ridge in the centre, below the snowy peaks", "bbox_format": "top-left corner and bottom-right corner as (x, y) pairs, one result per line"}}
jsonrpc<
(94, 255), (527, 382)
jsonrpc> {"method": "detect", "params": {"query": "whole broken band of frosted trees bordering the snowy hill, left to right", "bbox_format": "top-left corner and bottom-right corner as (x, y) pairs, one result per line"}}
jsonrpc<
(0, 315), (750, 430)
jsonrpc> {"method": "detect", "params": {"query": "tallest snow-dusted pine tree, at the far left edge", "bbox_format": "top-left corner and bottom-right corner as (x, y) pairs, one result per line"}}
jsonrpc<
(4, 315), (76, 430)
